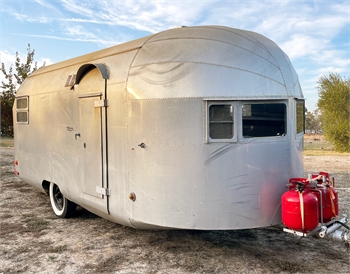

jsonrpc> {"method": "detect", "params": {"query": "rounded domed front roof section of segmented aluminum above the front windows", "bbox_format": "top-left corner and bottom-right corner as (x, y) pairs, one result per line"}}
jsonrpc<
(127, 26), (303, 99)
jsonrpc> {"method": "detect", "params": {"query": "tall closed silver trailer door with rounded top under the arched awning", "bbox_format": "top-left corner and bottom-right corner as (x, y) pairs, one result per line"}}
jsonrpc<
(76, 65), (109, 213)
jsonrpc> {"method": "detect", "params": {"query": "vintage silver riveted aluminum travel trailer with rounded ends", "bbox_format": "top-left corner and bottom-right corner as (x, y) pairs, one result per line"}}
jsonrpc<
(13, 26), (304, 230)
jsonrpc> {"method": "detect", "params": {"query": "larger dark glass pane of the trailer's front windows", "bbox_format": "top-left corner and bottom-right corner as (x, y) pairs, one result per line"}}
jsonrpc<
(242, 103), (287, 138)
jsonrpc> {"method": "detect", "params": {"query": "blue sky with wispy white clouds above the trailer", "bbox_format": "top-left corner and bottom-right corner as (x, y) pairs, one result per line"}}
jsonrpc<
(0, 0), (350, 111)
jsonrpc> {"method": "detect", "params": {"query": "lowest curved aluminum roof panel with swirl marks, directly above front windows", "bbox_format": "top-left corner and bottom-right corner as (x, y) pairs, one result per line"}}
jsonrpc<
(128, 63), (287, 99)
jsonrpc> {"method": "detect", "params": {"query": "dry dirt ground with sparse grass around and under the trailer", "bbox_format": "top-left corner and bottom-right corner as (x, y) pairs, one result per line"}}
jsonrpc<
(0, 148), (350, 274)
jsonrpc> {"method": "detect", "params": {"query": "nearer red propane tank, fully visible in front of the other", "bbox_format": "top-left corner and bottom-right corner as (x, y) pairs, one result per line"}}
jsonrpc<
(282, 179), (318, 232)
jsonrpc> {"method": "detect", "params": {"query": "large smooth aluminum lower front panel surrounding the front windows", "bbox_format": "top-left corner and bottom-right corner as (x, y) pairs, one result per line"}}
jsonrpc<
(128, 99), (302, 229)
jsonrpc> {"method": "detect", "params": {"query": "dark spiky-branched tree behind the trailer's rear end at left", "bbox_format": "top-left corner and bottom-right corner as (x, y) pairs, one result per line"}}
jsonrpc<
(0, 44), (45, 136)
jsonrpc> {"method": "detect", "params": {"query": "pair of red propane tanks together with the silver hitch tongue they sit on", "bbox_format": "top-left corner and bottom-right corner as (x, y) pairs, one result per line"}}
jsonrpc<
(282, 172), (350, 248)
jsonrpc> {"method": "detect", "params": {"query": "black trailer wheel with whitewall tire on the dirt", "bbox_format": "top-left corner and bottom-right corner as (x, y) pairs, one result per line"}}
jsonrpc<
(49, 182), (77, 218)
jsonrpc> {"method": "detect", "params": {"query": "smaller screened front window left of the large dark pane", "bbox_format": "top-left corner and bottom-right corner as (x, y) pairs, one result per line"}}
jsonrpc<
(209, 104), (234, 139)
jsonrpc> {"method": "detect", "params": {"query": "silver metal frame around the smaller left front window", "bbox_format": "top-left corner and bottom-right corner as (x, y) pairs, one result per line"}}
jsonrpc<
(205, 100), (238, 143)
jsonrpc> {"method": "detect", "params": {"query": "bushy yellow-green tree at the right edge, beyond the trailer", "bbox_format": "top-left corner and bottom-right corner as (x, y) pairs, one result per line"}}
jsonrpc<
(317, 73), (350, 152)
